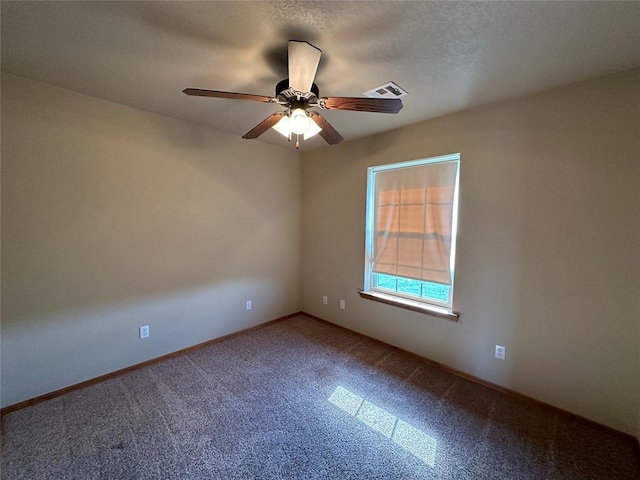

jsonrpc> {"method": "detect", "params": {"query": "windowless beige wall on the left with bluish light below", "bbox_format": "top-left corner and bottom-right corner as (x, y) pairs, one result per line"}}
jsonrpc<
(1, 74), (301, 406)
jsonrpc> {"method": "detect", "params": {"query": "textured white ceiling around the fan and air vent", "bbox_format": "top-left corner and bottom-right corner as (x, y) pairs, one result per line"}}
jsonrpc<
(1, 1), (640, 149)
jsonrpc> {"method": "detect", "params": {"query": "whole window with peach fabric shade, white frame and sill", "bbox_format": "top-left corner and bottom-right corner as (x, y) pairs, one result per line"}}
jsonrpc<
(361, 154), (460, 320)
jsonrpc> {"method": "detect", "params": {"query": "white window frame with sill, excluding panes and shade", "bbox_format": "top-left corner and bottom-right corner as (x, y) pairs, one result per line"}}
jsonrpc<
(360, 153), (460, 321)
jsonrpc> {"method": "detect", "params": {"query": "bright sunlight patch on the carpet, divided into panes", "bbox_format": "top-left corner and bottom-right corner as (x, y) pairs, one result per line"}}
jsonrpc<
(328, 386), (438, 467)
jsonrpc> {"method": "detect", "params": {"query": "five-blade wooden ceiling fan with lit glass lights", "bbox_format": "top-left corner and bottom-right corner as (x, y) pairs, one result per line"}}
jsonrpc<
(183, 40), (402, 148)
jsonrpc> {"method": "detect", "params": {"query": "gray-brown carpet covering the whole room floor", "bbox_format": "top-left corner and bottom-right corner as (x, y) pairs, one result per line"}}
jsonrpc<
(2, 316), (639, 480)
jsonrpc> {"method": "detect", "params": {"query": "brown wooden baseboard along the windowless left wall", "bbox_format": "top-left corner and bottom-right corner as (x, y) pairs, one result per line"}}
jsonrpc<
(0, 312), (304, 418)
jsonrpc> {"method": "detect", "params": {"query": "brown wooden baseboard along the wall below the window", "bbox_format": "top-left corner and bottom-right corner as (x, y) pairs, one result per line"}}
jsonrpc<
(300, 312), (640, 454)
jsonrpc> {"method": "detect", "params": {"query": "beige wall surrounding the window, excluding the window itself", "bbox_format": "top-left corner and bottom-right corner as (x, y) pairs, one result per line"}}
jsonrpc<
(302, 70), (640, 435)
